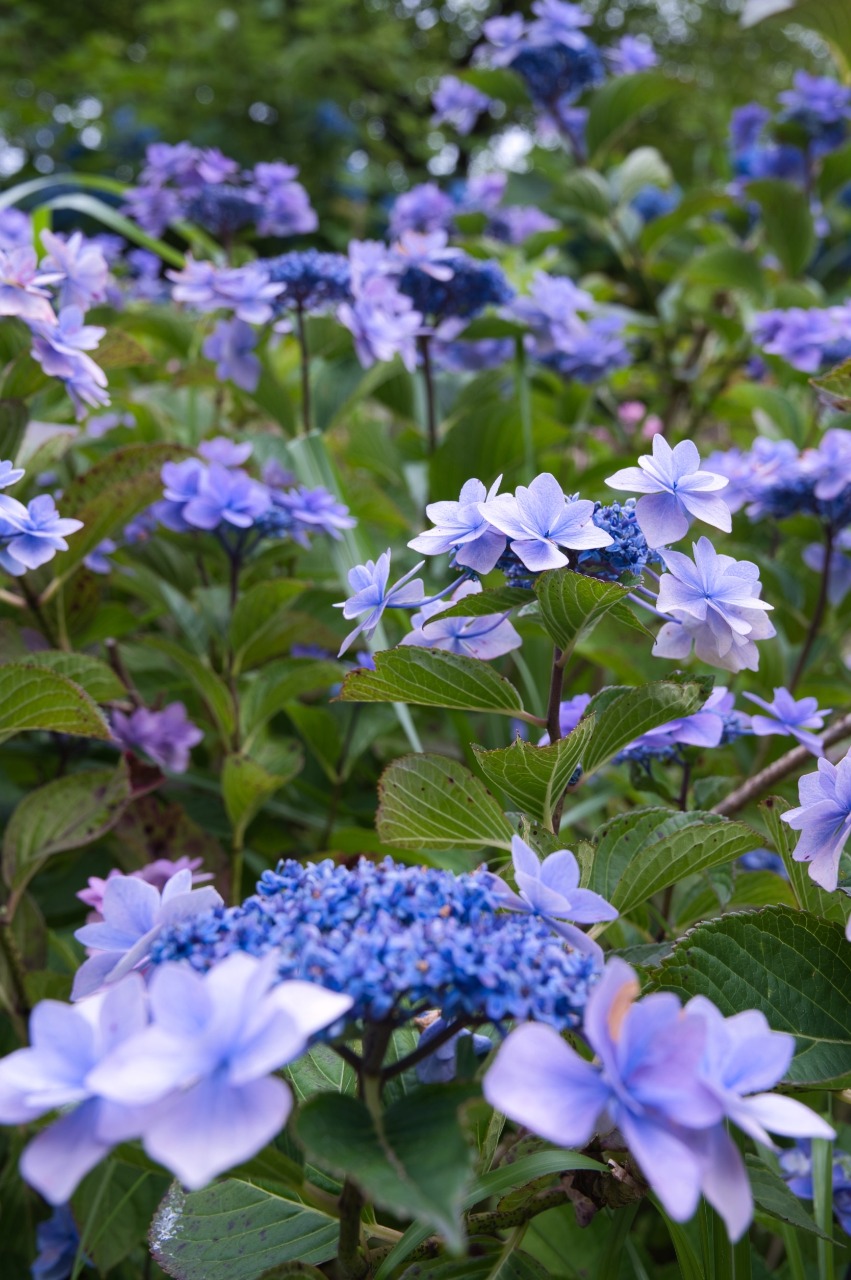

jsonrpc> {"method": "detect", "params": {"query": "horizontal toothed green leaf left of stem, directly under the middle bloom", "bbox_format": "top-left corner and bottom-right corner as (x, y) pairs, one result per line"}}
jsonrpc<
(339, 645), (522, 716)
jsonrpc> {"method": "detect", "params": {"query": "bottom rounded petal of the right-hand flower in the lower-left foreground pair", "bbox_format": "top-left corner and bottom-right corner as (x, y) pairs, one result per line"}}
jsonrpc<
(142, 1075), (293, 1190)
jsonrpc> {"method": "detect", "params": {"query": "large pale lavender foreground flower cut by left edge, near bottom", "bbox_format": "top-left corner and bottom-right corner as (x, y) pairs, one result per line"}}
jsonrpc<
(0, 975), (147, 1204)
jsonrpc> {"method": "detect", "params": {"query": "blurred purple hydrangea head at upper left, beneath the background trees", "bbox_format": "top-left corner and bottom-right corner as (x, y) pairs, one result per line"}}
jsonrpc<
(124, 142), (317, 239)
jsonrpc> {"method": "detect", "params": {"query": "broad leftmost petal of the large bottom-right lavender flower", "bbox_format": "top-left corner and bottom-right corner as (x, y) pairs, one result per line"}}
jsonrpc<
(482, 1023), (610, 1147)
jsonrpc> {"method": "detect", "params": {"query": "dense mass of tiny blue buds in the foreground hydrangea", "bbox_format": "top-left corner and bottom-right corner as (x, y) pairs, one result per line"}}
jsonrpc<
(152, 858), (599, 1029)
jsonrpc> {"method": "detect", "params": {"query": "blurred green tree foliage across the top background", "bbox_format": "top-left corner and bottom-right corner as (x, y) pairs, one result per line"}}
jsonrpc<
(0, 0), (828, 243)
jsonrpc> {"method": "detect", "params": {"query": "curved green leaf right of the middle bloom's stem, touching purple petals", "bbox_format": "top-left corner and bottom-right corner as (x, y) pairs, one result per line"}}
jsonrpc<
(582, 678), (709, 778)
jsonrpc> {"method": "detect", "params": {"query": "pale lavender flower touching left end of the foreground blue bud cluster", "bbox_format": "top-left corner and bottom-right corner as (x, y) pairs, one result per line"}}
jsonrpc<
(72, 869), (224, 1000)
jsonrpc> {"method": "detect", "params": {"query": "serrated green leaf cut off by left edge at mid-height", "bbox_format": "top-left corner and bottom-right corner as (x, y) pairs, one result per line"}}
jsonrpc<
(0, 662), (111, 742)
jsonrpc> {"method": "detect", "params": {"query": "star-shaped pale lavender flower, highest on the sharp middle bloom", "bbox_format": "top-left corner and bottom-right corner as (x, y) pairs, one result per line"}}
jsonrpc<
(605, 435), (732, 547)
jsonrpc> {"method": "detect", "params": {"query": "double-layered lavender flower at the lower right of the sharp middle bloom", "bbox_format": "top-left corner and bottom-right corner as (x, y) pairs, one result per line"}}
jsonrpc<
(653, 538), (774, 671)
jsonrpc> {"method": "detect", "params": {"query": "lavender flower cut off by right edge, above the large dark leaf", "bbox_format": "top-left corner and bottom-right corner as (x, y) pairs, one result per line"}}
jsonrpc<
(781, 751), (851, 892)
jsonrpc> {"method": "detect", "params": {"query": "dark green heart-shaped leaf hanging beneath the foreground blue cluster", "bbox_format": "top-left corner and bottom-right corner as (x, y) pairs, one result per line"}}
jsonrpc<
(296, 1084), (473, 1251)
